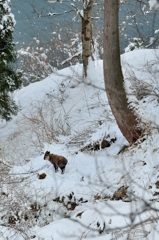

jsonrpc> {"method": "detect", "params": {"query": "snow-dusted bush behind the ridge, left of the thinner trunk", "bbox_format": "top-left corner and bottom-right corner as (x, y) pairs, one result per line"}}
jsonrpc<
(18, 27), (81, 86)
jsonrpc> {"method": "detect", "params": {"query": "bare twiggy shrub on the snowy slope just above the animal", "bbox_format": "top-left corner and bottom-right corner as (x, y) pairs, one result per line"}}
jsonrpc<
(18, 95), (70, 150)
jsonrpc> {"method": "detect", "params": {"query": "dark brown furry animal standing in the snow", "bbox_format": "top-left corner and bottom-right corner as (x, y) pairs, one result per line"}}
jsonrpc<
(44, 151), (68, 174)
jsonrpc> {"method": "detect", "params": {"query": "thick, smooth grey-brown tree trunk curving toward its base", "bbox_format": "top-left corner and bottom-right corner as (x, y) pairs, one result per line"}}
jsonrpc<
(103, 0), (141, 143)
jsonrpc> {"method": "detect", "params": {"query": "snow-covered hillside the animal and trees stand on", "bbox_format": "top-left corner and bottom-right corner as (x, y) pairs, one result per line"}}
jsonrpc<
(0, 50), (159, 240)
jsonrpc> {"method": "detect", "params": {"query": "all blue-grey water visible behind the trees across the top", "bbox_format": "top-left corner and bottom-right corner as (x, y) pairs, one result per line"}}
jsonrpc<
(11, 0), (159, 52)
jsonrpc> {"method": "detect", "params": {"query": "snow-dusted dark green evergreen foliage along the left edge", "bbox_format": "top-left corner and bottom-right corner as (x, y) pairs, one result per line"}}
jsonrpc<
(0, 0), (21, 121)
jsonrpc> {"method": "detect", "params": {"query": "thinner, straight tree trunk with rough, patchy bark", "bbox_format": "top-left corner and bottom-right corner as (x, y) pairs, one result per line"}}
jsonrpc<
(82, 0), (94, 77)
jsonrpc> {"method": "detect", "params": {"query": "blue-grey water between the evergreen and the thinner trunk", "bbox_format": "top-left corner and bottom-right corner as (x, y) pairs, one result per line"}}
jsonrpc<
(11, 0), (78, 43)
